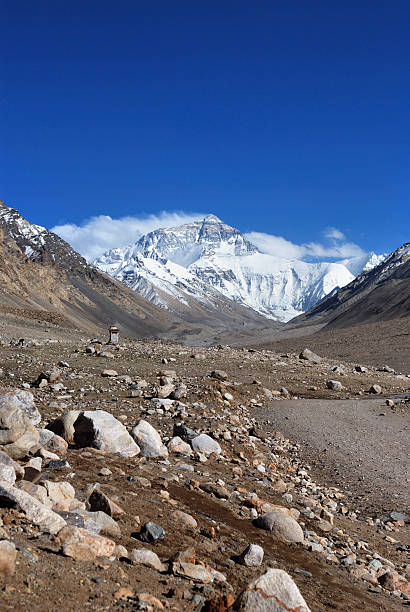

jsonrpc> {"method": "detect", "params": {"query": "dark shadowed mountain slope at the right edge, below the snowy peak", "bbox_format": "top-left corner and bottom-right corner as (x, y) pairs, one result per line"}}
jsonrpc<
(292, 243), (410, 333)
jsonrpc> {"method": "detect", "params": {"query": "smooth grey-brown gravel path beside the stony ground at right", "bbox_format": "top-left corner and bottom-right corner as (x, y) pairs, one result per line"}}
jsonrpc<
(257, 399), (410, 513)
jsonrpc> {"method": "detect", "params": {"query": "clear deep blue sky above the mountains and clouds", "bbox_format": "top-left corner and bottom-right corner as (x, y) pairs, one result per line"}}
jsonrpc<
(0, 0), (410, 252)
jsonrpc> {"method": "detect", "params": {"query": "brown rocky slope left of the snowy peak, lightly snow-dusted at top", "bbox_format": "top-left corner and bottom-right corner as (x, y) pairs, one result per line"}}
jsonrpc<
(0, 201), (272, 344)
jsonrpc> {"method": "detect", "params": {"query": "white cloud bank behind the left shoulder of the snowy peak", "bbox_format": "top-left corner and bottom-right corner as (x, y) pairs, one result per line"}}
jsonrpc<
(51, 211), (204, 261)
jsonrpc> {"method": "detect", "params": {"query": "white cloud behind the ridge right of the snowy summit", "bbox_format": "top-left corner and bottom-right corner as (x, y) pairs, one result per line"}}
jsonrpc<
(245, 228), (364, 260)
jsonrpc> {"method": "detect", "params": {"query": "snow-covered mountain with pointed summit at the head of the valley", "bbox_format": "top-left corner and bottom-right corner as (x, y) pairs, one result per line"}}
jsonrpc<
(94, 215), (382, 322)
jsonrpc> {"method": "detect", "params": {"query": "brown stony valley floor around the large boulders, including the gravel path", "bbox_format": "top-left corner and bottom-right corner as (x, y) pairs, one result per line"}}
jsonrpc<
(0, 325), (410, 612)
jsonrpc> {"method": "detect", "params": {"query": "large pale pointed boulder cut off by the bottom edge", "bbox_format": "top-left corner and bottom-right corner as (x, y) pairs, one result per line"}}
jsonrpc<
(235, 569), (310, 612)
